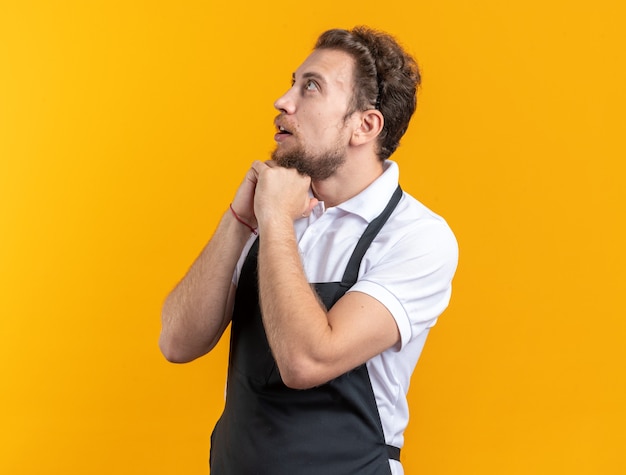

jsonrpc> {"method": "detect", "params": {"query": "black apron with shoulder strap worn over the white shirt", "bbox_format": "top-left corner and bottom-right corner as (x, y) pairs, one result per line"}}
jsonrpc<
(210, 186), (402, 475)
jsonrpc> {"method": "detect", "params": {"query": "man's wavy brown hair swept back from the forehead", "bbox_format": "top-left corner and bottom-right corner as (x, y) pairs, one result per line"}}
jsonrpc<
(315, 26), (421, 160)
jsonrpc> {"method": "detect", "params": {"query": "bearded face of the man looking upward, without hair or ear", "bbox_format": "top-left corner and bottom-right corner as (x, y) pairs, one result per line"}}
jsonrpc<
(272, 49), (354, 180)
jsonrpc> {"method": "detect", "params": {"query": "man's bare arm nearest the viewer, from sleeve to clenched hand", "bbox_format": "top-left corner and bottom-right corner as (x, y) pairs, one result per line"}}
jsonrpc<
(254, 163), (400, 389)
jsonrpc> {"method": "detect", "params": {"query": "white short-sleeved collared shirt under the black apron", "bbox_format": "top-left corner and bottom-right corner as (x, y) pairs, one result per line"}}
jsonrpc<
(234, 160), (458, 475)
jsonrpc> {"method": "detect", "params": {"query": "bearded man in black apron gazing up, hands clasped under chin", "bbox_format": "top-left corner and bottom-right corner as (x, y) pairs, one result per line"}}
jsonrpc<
(160, 28), (457, 475)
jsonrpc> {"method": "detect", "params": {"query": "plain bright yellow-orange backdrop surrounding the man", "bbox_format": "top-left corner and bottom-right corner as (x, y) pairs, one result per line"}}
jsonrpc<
(0, 0), (626, 475)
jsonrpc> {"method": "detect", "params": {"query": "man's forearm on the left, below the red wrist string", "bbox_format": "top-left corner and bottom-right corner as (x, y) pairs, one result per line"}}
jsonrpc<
(159, 211), (250, 363)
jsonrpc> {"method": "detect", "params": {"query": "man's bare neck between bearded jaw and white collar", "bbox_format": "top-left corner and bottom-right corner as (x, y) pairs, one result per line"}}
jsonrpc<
(311, 158), (383, 208)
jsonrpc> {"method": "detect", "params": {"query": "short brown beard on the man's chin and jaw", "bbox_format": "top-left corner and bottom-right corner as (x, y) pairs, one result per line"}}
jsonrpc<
(272, 140), (346, 181)
